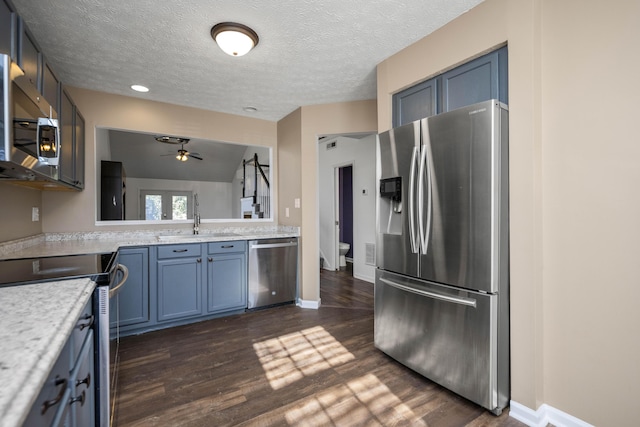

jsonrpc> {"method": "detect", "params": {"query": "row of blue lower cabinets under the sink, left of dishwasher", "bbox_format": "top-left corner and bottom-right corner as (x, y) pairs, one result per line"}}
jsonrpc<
(117, 240), (247, 336)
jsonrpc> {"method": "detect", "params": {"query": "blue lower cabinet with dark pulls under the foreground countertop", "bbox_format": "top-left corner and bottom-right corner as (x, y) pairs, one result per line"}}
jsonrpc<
(23, 300), (96, 427)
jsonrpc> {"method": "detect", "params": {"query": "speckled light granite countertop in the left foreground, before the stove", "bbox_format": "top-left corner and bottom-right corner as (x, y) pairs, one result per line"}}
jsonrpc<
(0, 279), (95, 427)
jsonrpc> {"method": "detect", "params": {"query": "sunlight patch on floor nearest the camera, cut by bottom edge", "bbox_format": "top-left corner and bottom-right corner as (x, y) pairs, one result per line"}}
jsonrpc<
(285, 374), (426, 427)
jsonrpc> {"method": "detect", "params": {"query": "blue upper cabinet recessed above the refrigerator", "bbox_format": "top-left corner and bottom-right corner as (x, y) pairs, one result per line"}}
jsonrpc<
(392, 46), (509, 127)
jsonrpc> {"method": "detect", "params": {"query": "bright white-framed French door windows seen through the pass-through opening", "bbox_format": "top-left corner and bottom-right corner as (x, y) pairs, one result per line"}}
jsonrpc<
(140, 190), (193, 221)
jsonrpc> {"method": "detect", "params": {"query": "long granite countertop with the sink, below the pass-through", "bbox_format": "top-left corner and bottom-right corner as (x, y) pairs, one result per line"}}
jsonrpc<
(0, 227), (299, 260)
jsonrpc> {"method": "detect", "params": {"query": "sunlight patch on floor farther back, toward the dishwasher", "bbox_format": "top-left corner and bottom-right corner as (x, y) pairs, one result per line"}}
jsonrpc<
(253, 326), (354, 390)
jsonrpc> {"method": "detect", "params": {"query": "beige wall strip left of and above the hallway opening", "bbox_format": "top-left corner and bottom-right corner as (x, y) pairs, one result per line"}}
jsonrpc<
(300, 100), (376, 301)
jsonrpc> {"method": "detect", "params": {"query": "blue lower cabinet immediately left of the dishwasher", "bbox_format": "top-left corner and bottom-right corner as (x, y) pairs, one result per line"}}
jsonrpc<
(207, 241), (247, 313)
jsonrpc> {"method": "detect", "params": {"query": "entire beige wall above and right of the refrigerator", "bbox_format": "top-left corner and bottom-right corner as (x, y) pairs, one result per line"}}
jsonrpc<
(378, 0), (640, 426)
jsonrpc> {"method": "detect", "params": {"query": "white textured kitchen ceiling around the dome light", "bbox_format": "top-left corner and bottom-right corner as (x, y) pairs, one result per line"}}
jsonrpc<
(12, 0), (482, 121)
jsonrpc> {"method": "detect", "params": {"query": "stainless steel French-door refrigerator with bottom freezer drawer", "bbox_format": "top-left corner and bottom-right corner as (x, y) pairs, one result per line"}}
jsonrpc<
(374, 100), (510, 414)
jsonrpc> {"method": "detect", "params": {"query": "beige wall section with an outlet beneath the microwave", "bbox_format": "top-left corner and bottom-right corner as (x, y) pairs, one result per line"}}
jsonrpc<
(0, 183), (42, 242)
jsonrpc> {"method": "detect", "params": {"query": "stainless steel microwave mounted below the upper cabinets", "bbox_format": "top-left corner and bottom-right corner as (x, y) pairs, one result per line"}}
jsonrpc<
(0, 54), (60, 181)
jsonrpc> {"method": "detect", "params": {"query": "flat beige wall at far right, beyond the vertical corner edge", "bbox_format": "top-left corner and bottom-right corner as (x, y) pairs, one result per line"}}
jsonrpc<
(542, 0), (640, 426)
